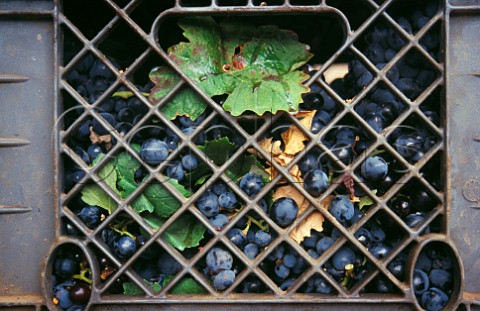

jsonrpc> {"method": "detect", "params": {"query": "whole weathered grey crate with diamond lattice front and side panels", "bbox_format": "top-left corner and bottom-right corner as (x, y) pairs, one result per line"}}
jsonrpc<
(0, 0), (480, 310)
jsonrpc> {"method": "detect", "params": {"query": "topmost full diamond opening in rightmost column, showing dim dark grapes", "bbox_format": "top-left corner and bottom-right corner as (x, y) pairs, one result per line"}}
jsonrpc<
(392, 48), (440, 100)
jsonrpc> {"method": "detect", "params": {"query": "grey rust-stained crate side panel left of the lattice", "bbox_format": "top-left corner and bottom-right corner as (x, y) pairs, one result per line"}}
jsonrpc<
(0, 8), (55, 310)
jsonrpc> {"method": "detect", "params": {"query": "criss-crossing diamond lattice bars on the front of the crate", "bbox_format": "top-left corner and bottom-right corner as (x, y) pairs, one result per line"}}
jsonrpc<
(52, 1), (454, 304)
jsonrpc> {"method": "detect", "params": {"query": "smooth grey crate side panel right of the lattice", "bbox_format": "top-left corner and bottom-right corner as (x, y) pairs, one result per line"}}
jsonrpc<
(446, 15), (480, 293)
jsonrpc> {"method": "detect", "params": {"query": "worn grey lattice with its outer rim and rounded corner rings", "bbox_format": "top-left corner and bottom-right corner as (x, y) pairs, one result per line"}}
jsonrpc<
(4, 0), (478, 310)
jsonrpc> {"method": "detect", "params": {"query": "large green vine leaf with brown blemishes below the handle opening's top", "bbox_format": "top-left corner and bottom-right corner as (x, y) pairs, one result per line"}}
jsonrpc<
(149, 16), (313, 119)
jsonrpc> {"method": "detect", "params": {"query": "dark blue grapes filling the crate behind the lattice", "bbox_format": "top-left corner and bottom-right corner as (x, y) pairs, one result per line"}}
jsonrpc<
(57, 1), (451, 302)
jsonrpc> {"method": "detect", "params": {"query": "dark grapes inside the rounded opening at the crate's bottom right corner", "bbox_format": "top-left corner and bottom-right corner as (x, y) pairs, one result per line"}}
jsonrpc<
(412, 243), (454, 311)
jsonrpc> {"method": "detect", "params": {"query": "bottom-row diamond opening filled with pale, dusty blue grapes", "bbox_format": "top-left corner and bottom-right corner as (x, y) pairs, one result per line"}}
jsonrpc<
(196, 243), (243, 292)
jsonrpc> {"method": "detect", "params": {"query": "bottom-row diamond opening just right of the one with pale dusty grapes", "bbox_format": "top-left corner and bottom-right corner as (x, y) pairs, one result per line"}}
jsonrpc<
(260, 243), (309, 291)
